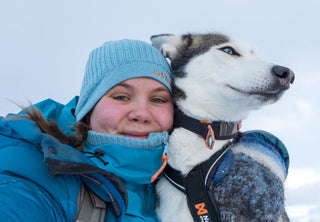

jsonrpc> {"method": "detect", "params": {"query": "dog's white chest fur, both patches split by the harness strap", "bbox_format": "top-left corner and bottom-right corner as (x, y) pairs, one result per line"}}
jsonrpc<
(156, 129), (230, 222)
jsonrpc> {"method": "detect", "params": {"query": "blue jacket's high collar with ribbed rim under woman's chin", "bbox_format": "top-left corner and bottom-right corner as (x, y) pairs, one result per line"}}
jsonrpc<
(83, 131), (168, 184)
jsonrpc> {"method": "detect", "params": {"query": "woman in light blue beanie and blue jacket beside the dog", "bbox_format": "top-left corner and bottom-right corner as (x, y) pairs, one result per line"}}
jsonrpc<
(0, 40), (173, 222)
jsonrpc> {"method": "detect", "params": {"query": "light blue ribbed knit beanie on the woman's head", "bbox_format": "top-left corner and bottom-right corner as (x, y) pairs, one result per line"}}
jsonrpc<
(76, 39), (171, 121)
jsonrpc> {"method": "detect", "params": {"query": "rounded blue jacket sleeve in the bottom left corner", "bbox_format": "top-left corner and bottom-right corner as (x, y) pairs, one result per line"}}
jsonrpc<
(0, 173), (65, 222)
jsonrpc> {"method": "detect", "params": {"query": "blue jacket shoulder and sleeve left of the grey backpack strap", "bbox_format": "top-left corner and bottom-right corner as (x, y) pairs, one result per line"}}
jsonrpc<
(0, 118), (81, 221)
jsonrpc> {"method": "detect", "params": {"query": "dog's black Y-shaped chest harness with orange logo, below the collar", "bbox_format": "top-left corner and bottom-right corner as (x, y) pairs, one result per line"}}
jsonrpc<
(164, 144), (230, 222)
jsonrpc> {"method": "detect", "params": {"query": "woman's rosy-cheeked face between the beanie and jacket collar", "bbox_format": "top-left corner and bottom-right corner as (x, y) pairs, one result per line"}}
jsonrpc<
(90, 77), (173, 139)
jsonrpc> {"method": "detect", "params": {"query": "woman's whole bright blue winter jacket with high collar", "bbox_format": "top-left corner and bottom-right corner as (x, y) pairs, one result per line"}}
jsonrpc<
(0, 97), (168, 222)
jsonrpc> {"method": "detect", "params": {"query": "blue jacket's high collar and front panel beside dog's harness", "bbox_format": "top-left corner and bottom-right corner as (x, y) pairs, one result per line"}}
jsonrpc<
(83, 131), (168, 221)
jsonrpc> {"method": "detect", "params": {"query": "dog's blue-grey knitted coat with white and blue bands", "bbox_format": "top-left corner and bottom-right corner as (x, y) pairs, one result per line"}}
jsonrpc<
(211, 135), (287, 222)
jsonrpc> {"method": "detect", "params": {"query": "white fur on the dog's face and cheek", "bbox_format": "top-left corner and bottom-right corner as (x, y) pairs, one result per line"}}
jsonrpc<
(176, 43), (274, 121)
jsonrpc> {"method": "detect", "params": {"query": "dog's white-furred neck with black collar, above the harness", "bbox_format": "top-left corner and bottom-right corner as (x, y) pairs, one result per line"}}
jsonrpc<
(168, 110), (240, 173)
